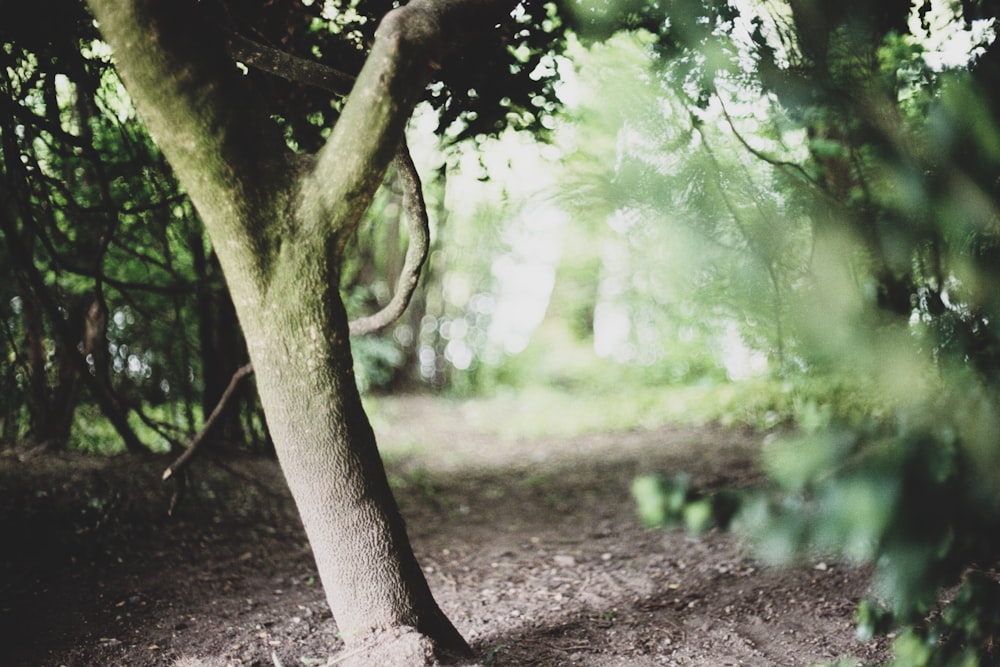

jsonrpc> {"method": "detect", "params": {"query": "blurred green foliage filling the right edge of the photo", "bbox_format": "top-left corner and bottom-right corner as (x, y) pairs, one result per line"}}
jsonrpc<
(608, 2), (1000, 665)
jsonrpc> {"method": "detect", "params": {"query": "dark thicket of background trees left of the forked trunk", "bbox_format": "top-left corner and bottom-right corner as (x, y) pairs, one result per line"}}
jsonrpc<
(0, 5), (265, 451)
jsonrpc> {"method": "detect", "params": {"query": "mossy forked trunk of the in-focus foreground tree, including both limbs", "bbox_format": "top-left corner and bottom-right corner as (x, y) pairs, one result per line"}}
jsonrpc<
(90, 0), (516, 653)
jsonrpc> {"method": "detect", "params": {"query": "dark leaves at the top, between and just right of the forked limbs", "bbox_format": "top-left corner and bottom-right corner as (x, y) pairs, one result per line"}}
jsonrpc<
(200, 0), (563, 151)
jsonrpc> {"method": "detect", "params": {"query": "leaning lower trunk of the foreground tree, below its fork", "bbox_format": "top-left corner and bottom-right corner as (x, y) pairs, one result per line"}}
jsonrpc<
(244, 266), (468, 652)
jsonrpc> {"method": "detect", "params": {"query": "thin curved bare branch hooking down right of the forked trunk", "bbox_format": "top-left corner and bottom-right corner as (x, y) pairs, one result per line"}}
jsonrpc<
(350, 139), (430, 336)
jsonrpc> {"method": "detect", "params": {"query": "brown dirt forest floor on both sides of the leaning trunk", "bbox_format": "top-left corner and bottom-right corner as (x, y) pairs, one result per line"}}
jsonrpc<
(0, 396), (886, 667)
